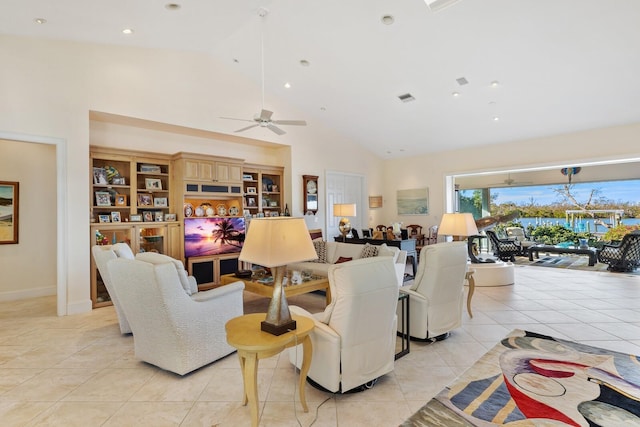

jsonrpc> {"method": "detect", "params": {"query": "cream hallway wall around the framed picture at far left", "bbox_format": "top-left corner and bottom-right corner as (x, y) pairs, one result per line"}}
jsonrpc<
(0, 139), (56, 301)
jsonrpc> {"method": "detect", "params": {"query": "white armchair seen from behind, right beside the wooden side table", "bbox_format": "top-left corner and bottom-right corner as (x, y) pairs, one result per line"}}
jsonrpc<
(289, 257), (398, 392)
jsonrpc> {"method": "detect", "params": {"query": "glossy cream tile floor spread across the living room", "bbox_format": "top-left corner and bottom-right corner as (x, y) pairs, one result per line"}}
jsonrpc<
(0, 266), (640, 427)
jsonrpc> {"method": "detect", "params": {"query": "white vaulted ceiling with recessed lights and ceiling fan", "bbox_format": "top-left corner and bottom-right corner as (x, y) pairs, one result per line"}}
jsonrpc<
(0, 0), (640, 158)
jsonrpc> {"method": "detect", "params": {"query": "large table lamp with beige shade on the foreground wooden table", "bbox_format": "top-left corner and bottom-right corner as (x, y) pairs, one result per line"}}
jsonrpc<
(239, 217), (318, 335)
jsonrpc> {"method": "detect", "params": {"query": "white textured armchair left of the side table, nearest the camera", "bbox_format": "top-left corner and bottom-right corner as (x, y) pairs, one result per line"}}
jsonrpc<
(108, 259), (244, 375)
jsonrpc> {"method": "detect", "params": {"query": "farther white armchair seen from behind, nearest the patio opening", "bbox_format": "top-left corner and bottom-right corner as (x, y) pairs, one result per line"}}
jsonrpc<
(398, 242), (467, 340)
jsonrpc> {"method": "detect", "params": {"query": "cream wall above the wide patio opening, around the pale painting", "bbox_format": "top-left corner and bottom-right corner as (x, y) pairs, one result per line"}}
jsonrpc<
(383, 124), (640, 231)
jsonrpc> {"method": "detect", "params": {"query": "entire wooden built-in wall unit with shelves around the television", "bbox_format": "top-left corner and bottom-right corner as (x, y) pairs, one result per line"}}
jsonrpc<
(89, 146), (286, 307)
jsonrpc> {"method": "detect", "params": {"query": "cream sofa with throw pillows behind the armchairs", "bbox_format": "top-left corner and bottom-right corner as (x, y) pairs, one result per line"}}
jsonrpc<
(287, 240), (407, 287)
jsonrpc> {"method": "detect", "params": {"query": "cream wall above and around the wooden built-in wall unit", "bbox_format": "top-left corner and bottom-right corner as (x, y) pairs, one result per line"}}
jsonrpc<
(0, 36), (382, 314)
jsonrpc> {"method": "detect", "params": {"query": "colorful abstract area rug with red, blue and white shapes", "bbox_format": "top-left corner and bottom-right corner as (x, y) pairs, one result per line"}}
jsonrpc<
(402, 329), (640, 427)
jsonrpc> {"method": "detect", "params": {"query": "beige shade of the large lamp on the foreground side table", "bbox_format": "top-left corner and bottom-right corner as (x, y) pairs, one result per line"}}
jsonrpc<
(239, 217), (318, 268)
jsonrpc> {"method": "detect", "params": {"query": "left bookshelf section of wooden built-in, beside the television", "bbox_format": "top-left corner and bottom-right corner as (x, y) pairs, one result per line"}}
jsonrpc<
(89, 146), (182, 307)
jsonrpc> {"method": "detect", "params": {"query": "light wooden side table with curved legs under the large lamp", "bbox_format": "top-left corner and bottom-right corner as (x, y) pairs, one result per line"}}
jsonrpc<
(225, 313), (314, 427)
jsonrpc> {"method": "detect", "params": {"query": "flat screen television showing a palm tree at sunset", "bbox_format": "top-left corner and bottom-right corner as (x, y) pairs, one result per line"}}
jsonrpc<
(184, 217), (245, 258)
